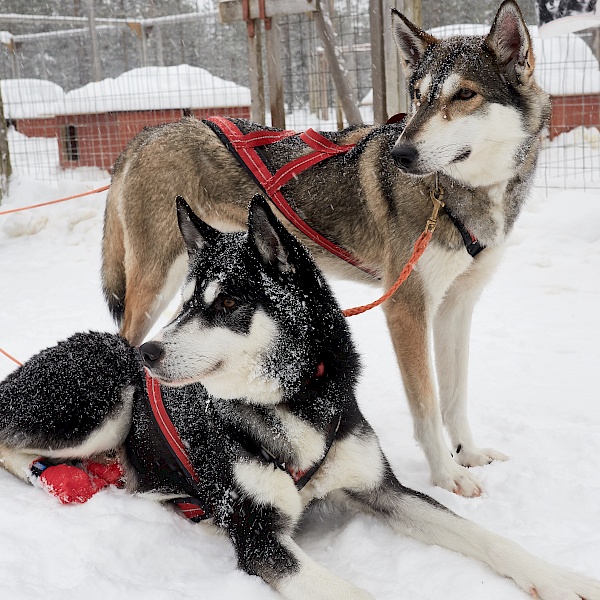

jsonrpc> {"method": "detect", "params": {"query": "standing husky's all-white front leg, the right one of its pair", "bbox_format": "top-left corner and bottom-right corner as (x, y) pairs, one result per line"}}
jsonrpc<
(434, 248), (508, 467)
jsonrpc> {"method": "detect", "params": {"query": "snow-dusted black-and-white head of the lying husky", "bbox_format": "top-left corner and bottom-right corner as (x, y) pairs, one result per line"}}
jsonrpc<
(140, 196), (348, 404)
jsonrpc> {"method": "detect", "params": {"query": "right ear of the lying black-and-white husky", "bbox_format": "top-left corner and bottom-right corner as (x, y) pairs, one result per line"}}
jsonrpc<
(248, 194), (295, 273)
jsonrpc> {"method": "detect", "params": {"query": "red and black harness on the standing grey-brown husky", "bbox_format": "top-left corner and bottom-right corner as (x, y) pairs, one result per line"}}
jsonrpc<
(203, 116), (485, 262)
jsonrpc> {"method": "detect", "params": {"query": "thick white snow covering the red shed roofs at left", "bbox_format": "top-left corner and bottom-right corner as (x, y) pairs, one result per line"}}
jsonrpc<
(1, 65), (250, 119)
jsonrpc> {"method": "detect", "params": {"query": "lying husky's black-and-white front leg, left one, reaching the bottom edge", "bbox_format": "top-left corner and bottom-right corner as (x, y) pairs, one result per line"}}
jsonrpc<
(229, 462), (373, 600)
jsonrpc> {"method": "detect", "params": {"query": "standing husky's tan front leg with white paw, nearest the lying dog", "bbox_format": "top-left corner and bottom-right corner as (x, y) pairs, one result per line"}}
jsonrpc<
(384, 297), (483, 497)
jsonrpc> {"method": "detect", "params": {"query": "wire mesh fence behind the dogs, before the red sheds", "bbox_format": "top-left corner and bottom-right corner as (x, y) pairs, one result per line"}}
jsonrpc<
(0, 0), (600, 188)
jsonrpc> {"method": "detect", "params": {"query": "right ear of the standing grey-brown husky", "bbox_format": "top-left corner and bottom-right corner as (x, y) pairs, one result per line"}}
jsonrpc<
(485, 0), (535, 82)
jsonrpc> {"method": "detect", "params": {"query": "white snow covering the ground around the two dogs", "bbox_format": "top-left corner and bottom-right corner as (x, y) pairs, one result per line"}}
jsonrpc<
(0, 137), (600, 600)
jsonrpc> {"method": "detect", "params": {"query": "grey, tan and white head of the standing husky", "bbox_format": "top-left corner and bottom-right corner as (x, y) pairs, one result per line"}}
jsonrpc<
(392, 0), (550, 187)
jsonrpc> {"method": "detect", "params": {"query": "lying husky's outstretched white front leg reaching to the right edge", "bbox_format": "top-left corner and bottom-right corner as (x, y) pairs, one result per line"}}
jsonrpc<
(345, 435), (600, 600)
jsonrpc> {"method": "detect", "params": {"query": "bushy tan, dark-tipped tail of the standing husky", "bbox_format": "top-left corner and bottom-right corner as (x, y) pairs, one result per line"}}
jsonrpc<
(101, 188), (126, 326)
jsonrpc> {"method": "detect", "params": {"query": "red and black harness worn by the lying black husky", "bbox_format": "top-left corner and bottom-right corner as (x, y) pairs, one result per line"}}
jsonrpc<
(146, 365), (341, 523)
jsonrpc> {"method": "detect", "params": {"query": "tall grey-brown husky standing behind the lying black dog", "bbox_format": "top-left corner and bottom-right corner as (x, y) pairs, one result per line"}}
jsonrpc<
(102, 0), (550, 496)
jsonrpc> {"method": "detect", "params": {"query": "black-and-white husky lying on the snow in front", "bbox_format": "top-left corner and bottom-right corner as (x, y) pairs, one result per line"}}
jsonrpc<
(0, 197), (600, 600)
